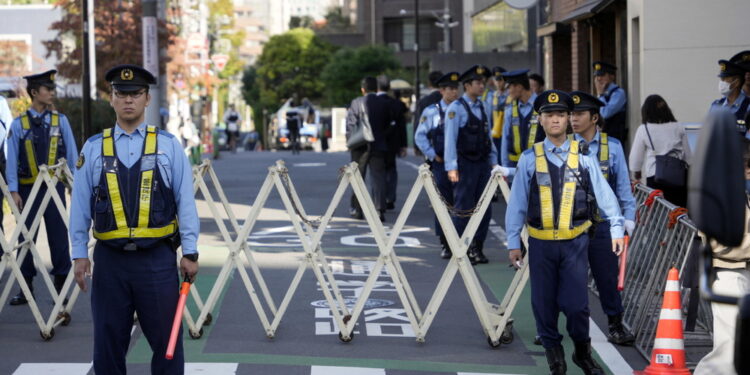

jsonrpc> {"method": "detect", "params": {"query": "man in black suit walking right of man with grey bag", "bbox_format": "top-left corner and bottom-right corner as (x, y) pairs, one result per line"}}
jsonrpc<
(377, 75), (409, 210)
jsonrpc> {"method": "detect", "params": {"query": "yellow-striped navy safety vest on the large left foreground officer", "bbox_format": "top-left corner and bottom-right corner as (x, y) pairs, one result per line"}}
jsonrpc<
(92, 126), (178, 248)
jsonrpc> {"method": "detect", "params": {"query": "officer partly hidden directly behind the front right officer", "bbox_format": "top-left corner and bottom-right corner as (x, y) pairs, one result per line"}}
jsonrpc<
(570, 91), (635, 345)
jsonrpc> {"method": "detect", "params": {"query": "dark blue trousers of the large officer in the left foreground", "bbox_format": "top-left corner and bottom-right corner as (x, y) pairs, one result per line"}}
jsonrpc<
(91, 243), (185, 375)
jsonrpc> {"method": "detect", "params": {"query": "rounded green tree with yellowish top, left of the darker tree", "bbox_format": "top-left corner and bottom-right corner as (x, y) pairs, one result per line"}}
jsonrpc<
(251, 28), (334, 112)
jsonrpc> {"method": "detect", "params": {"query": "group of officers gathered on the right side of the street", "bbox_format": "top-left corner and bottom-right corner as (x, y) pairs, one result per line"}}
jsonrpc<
(415, 62), (635, 374)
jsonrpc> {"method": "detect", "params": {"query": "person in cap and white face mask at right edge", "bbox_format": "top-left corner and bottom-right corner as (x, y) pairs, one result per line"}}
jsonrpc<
(709, 60), (750, 137)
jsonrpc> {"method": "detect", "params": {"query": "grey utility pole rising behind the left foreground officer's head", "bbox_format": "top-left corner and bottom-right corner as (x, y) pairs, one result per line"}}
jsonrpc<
(143, 0), (164, 126)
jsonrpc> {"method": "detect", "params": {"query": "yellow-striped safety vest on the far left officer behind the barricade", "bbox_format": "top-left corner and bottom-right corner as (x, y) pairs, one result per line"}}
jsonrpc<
(18, 111), (65, 185)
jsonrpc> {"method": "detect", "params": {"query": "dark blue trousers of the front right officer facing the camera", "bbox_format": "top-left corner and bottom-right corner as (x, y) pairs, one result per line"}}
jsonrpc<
(529, 233), (589, 349)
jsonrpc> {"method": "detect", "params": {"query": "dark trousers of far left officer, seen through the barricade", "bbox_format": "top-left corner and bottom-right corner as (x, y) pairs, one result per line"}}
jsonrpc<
(18, 183), (70, 277)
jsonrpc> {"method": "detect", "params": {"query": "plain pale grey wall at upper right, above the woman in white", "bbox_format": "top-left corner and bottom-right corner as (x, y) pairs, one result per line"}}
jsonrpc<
(626, 0), (750, 126)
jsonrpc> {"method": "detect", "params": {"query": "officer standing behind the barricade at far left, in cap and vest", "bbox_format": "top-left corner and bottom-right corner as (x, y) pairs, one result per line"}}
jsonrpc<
(5, 70), (78, 305)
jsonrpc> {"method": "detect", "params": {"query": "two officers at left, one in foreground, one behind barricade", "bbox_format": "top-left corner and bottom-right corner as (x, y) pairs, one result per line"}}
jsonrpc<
(2, 65), (199, 374)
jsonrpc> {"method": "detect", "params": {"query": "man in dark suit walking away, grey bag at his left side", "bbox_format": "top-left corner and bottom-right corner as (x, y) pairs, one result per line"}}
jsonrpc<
(346, 77), (391, 220)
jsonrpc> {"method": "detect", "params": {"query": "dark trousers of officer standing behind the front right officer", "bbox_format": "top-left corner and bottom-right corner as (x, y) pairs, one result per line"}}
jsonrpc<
(589, 222), (625, 316)
